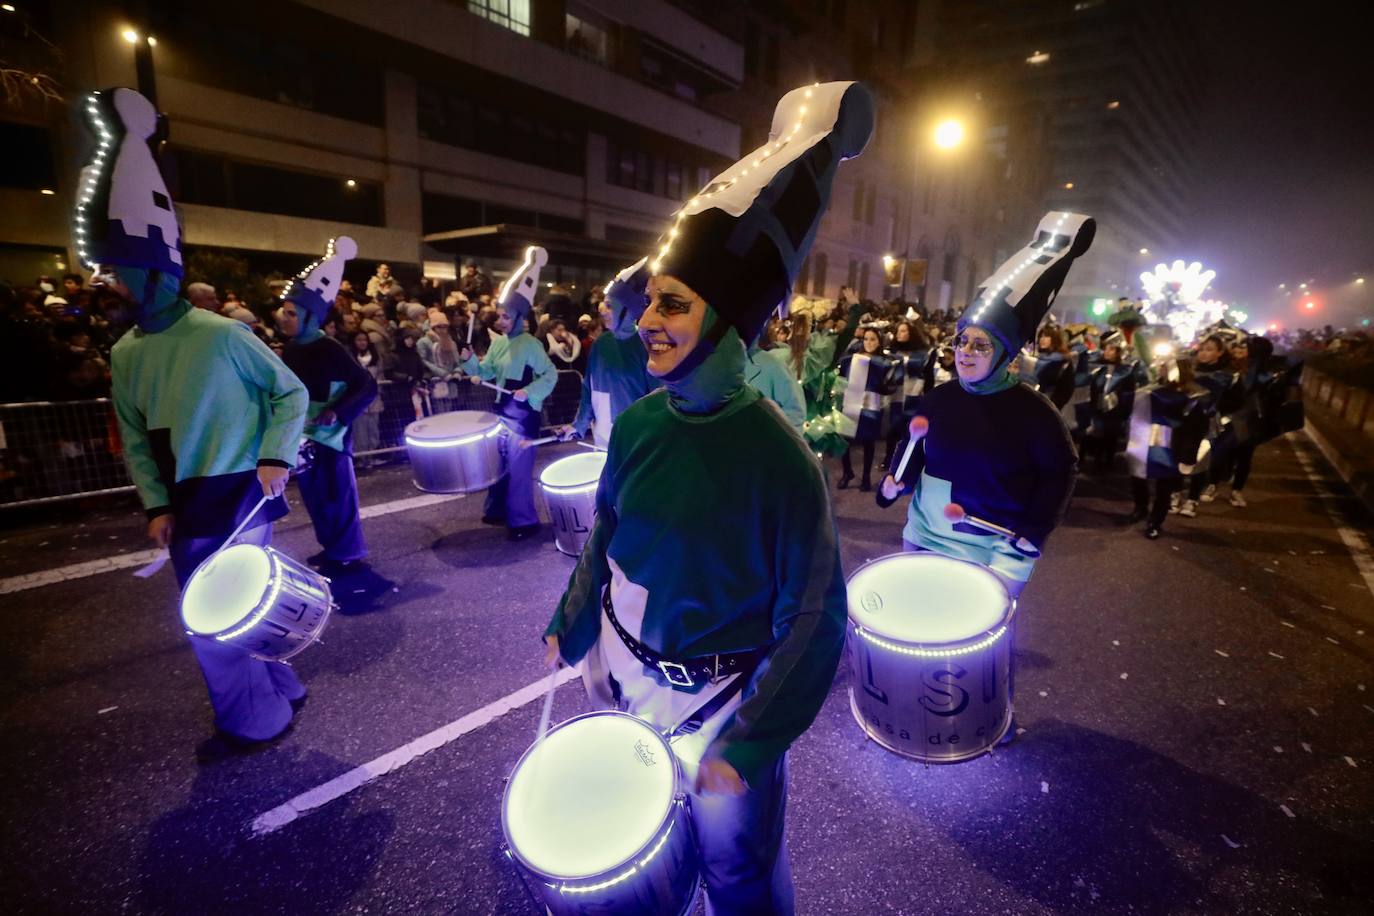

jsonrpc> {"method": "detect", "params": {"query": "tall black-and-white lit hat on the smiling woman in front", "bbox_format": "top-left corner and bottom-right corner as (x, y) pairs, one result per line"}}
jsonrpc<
(649, 82), (874, 369)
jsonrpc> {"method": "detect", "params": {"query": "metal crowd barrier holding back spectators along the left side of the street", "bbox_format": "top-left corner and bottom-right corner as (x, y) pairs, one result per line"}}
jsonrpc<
(0, 369), (583, 508)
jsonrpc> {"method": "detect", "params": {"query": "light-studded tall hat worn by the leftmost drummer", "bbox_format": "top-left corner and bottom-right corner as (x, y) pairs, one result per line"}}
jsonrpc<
(74, 88), (184, 277)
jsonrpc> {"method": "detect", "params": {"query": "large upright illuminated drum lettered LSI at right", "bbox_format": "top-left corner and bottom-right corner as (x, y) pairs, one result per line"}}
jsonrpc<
(846, 553), (1015, 764)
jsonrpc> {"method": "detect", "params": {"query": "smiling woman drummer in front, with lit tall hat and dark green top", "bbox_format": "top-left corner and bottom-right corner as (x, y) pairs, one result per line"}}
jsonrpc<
(547, 82), (874, 913)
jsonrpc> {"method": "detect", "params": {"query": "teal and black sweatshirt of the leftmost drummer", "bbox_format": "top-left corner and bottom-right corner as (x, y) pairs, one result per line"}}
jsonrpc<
(110, 305), (308, 537)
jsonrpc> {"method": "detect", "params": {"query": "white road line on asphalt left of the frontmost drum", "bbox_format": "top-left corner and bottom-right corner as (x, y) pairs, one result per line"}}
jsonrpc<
(249, 667), (577, 836)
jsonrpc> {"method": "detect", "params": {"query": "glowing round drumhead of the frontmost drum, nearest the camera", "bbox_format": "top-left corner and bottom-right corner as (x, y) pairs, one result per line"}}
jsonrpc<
(502, 711), (677, 879)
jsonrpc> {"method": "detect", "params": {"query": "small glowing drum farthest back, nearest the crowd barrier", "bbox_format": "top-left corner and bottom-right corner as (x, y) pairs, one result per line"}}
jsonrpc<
(405, 411), (506, 493)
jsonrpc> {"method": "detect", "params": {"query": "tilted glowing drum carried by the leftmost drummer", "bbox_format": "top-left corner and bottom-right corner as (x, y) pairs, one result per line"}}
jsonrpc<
(181, 544), (334, 662)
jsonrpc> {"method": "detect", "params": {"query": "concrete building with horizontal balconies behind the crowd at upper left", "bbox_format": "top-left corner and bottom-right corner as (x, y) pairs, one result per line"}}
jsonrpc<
(0, 0), (743, 293)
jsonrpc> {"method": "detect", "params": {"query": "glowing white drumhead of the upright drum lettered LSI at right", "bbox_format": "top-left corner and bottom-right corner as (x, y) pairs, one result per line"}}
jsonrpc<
(848, 553), (1011, 645)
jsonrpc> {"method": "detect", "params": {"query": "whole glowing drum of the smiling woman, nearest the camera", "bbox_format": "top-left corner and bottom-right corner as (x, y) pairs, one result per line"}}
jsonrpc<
(502, 711), (699, 913)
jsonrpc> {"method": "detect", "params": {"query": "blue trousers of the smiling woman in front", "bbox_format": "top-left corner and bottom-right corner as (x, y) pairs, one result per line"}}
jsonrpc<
(691, 754), (793, 916)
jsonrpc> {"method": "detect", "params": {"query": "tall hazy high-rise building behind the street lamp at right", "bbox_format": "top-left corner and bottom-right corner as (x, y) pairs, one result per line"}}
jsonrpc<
(930, 0), (1204, 309)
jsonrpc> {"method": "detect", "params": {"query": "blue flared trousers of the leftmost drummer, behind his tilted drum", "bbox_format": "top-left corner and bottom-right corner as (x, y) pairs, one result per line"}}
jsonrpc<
(169, 525), (305, 742)
